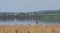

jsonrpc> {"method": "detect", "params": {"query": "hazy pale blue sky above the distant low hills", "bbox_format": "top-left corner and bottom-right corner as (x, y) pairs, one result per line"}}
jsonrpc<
(0, 0), (60, 12)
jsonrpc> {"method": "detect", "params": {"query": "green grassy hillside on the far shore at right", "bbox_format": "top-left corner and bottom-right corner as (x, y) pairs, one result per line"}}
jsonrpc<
(41, 13), (60, 21)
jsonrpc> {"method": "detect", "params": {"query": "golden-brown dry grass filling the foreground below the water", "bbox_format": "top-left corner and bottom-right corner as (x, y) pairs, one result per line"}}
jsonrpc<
(0, 25), (60, 33)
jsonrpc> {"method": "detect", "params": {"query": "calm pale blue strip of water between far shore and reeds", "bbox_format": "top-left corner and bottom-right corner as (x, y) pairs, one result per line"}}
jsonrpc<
(0, 20), (60, 25)
